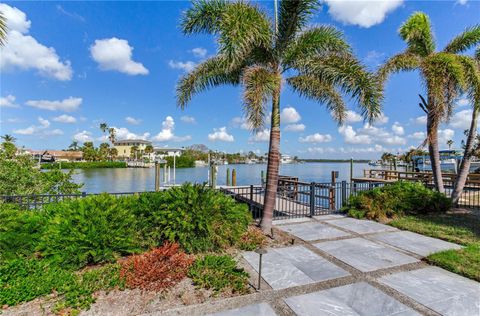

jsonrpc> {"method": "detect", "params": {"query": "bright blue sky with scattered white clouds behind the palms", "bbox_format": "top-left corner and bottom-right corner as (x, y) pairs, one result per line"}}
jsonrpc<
(0, 0), (480, 159)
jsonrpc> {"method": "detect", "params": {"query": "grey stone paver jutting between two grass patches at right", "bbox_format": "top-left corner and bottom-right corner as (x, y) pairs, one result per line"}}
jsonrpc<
(371, 231), (462, 257)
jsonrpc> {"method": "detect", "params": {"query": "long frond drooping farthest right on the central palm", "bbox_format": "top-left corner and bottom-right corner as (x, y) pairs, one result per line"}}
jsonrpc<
(296, 55), (383, 122)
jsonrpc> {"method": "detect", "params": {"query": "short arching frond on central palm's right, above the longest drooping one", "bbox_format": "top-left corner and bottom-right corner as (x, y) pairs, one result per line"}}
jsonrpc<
(283, 25), (351, 69)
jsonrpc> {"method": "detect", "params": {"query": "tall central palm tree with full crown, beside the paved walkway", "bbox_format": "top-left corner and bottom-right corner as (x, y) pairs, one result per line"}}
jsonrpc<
(177, 0), (382, 234)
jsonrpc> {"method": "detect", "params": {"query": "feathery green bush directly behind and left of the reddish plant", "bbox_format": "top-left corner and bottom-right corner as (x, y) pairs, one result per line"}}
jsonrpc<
(39, 194), (140, 268)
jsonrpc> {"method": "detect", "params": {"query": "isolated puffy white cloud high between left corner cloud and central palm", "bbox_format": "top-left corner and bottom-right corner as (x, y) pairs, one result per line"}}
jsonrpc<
(90, 37), (148, 76)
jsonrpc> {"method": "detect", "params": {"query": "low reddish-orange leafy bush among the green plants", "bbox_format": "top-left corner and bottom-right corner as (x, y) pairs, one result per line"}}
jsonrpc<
(121, 243), (194, 291)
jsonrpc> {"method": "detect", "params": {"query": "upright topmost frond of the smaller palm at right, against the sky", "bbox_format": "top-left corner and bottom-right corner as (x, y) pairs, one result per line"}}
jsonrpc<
(399, 12), (435, 57)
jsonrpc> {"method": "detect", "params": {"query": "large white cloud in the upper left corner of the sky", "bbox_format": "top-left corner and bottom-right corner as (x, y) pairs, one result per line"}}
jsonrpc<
(0, 3), (73, 81)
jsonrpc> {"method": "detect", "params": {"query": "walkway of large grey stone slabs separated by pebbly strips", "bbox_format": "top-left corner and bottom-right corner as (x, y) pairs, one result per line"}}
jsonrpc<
(207, 215), (480, 316)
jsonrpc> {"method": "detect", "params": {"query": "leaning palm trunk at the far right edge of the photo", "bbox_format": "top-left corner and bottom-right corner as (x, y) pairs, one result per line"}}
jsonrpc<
(452, 106), (479, 205)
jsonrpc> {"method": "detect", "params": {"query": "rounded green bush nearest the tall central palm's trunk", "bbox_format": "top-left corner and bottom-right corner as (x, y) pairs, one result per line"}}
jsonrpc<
(134, 184), (252, 252)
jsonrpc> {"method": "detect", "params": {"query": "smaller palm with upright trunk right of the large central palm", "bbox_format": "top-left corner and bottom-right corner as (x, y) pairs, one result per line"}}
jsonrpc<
(379, 12), (480, 192)
